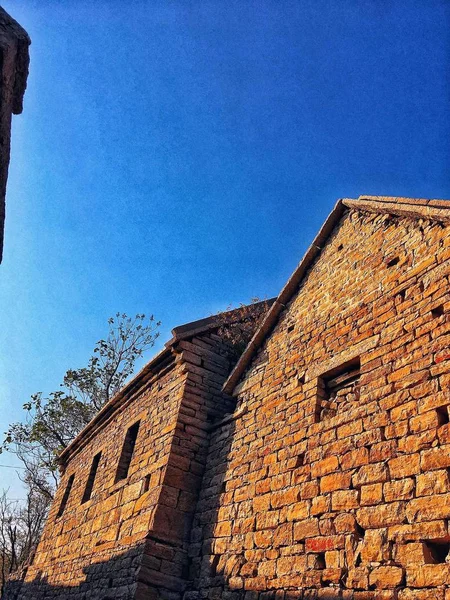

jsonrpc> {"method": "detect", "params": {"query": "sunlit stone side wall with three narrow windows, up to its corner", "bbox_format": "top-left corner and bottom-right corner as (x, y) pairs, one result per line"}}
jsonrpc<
(10, 354), (184, 599)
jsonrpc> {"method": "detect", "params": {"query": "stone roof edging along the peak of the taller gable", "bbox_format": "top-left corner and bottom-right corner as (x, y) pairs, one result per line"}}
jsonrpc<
(223, 196), (450, 394)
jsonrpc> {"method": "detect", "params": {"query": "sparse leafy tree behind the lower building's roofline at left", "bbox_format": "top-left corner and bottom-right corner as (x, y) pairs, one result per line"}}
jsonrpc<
(0, 313), (160, 497)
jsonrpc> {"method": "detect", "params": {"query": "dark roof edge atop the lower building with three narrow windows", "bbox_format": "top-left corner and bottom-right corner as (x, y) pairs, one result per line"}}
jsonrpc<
(58, 298), (274, 464)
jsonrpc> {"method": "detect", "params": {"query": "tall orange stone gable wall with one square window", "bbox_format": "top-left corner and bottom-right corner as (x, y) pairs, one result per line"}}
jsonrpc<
(190, 211), (450, 600)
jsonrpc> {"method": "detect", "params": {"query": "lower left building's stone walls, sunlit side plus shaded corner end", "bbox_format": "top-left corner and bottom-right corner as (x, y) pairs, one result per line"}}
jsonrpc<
(5, 330), (239, 600)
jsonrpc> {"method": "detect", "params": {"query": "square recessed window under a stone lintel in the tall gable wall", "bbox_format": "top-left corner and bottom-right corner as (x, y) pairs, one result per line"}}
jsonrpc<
(316, 358), (361, 421)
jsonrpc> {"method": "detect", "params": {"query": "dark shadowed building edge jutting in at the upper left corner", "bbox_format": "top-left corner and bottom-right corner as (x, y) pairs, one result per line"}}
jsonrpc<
(0, 7), (30, 263)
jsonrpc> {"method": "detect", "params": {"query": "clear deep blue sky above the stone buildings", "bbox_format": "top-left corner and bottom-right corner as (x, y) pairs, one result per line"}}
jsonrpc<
(0, 0), (450, 495)
